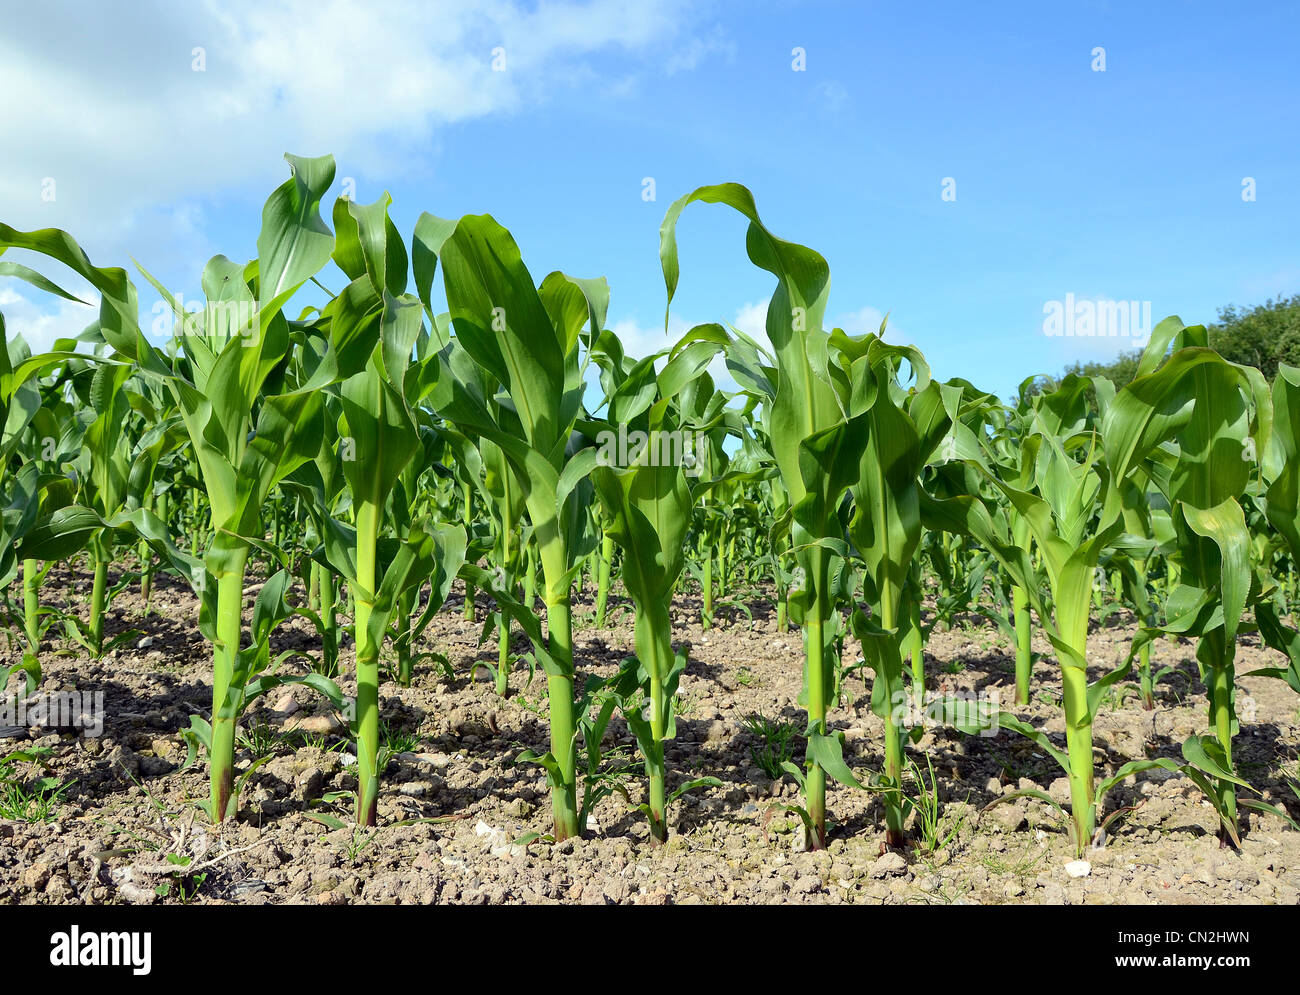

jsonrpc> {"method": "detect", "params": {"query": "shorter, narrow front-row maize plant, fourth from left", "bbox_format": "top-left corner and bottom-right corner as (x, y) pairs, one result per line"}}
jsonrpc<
(592, 325), (727, 843)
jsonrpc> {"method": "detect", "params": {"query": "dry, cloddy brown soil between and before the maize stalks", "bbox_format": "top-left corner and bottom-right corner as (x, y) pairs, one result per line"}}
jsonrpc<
(0, 561), (1300, 905)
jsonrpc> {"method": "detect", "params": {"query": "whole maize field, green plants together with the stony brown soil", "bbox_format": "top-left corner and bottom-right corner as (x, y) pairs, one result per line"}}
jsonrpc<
(0, 156), (1300, 904)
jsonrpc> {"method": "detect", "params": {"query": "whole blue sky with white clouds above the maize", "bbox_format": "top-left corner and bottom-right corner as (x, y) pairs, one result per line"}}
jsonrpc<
(0, 0), (1300, 395)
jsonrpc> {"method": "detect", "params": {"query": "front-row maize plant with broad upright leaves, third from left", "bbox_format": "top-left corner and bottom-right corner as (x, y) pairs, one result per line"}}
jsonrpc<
(412, 215), (608, 840)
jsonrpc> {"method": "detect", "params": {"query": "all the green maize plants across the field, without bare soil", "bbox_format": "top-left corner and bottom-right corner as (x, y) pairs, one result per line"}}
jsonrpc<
(0, 156), (1300, 852)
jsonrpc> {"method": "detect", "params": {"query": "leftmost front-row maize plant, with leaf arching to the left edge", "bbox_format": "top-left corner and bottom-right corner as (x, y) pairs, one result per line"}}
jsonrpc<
(0, 156), (378, 822)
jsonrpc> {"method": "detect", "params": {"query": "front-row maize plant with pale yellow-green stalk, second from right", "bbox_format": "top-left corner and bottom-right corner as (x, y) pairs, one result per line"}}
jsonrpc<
(926, 319), (1274, 853)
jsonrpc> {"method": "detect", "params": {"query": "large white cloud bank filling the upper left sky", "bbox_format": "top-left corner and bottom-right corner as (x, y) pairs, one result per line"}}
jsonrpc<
(0, 0), (711, 239)
